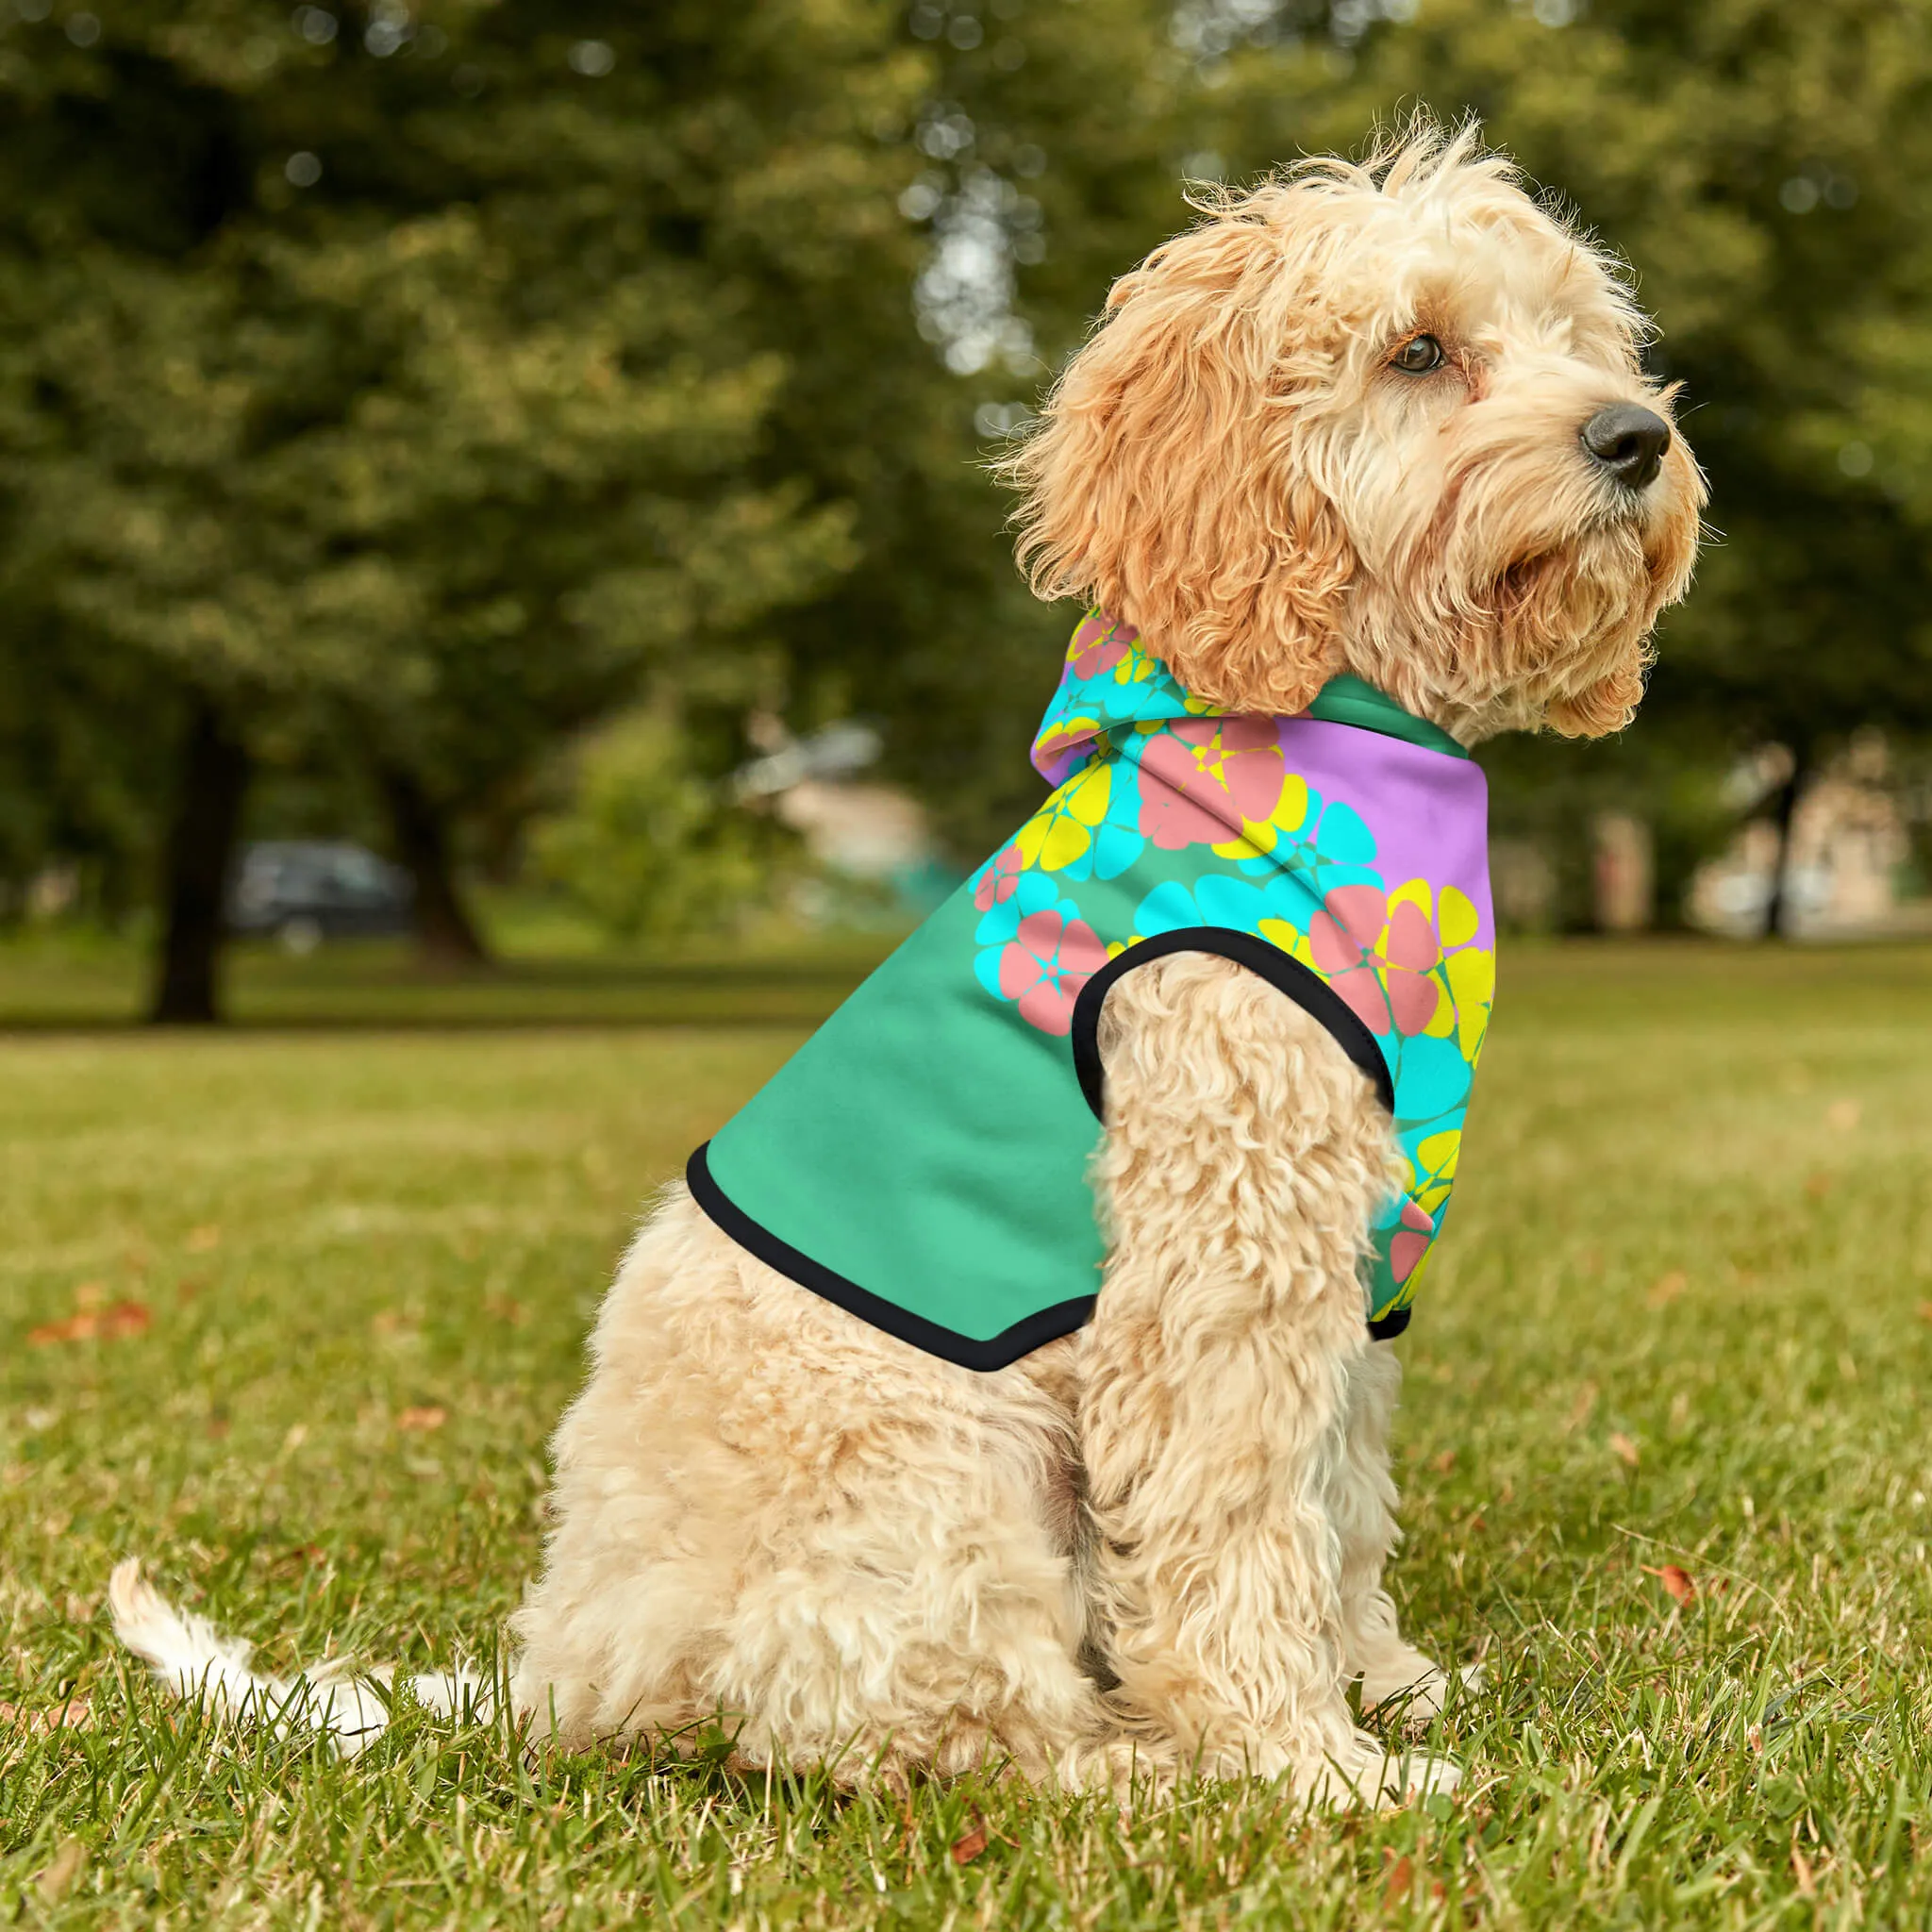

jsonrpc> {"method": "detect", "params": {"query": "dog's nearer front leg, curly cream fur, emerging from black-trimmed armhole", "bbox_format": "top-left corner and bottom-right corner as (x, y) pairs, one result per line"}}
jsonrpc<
(1080, 955), (1455, 1799)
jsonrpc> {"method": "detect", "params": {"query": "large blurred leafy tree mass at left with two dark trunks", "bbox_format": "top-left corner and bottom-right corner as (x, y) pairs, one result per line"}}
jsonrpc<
(0, 0), (904, 1020)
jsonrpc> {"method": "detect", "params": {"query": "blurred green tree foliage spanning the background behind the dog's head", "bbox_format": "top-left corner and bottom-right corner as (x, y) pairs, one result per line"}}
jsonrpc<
(0, 0), (1932, 981)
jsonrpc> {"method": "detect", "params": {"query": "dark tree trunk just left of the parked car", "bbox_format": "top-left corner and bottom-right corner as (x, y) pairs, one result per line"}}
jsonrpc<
(149, 697), (249, 1025)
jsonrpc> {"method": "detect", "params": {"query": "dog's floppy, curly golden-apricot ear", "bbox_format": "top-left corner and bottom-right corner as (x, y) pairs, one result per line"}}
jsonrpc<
(1001, 188), (1355, 713)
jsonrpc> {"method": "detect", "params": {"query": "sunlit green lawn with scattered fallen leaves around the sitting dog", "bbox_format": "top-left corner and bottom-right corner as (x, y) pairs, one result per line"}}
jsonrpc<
(0, 944), (1932, 1932)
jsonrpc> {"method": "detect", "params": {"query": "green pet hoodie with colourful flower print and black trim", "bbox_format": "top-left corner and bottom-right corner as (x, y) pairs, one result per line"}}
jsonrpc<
(688, 612), (1495, 1370)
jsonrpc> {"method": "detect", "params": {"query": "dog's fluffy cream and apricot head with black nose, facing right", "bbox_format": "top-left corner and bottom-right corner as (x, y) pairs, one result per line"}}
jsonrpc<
(1005, 124), (1704, 740)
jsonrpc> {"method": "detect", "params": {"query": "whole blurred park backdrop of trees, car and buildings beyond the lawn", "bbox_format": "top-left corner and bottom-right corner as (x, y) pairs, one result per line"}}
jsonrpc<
(0, 0), (1932, 1022)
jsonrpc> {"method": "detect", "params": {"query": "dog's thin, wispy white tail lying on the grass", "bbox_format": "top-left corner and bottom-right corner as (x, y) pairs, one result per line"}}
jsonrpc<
(108, 1557), (496, 1758)
